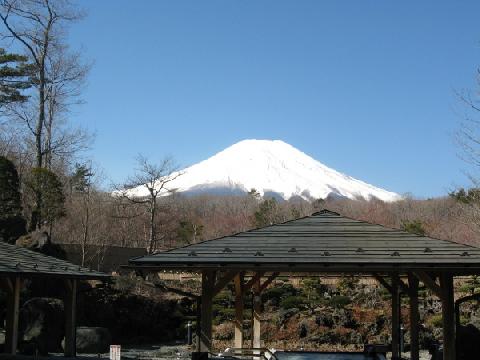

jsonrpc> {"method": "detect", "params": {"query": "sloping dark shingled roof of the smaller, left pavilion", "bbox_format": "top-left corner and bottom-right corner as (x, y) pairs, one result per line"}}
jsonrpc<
(0, 241), (109, 279)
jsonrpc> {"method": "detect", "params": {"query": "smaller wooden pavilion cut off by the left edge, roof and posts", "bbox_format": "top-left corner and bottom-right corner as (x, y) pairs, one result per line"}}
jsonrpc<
(0, 242), (109, 356)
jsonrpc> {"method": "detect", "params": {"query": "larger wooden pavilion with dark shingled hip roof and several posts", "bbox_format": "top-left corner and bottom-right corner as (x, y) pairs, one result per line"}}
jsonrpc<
(130, 210), (480, 360)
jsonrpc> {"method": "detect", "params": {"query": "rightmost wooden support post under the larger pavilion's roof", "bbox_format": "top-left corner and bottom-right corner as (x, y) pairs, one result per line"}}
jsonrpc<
(440, 273), (456, 360)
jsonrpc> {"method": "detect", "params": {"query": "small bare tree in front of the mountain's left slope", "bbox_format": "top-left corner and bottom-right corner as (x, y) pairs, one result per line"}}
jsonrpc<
(116, 155), (182, 254)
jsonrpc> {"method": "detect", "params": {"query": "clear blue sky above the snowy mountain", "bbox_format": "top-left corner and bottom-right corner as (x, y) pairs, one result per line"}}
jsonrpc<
(70, 0), (480, 197)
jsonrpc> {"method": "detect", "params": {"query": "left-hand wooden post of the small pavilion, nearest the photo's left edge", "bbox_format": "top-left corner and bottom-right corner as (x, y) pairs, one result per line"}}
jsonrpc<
(5, 276), (22, 355)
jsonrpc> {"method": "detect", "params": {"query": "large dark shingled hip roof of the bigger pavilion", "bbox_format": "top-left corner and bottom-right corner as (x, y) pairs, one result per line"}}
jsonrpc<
(130, 210), (480, 273)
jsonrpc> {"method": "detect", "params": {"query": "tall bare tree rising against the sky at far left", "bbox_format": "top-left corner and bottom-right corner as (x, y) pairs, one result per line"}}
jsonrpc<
(0, 0), (88, 167)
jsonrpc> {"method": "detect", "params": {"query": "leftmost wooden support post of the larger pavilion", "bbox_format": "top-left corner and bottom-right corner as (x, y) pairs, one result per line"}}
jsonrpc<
(198, 270), (215, 352)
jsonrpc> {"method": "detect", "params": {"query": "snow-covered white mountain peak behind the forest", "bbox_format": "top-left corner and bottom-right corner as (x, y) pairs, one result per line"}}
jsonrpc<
(124, 140), (401, 201)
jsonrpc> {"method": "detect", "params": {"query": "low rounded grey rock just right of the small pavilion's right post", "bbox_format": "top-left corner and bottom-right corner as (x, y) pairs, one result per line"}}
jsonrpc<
(62, 326), (112, 354)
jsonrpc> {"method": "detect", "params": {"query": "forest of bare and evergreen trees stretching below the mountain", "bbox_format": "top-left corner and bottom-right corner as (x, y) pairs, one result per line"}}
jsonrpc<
(0, 0), (480, 265)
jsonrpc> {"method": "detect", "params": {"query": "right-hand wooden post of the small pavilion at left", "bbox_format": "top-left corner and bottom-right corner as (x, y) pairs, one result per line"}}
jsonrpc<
(63, 279), (77, 357)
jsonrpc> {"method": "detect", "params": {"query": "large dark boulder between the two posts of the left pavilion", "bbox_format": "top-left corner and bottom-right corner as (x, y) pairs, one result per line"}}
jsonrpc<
(20, 298), (65, 355)
